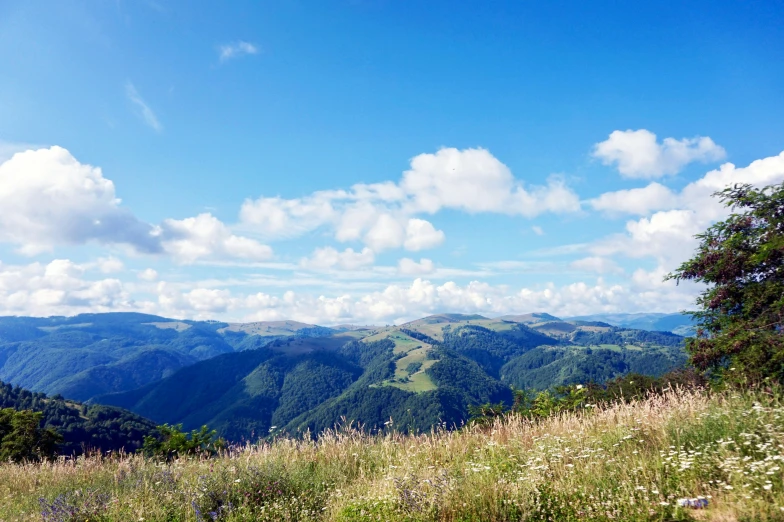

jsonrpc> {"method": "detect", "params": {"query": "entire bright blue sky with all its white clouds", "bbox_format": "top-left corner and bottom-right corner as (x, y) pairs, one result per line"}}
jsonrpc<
(0, 0), (784, 324)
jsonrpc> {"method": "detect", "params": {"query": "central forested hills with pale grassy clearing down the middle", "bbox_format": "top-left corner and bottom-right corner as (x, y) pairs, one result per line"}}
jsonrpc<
(89, 314), (685, 440)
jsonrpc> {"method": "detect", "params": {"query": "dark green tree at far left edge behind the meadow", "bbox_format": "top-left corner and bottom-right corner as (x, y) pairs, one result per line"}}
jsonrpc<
(0, 408), (63, 462)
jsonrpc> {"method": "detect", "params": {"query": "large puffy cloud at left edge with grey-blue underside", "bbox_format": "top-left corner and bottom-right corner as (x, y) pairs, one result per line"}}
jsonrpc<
(0, 147), (160, 255)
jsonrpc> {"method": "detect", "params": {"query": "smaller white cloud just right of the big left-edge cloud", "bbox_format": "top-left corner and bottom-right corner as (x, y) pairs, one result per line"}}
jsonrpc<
(160, 213), (272, 264)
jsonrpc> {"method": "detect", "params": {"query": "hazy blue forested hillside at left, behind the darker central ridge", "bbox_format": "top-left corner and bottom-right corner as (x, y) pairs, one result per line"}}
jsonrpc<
(0, 313), (333, 400)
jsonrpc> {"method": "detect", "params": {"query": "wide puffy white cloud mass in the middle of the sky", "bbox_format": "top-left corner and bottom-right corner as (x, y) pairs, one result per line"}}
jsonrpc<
(240, 144), (580, 252)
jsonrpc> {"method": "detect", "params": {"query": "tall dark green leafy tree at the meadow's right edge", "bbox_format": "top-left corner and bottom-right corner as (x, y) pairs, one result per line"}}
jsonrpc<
(668, 184), (784, 382)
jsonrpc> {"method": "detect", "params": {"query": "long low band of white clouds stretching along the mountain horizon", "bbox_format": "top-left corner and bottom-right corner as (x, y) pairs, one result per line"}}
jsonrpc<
(0, 258), (695, 325)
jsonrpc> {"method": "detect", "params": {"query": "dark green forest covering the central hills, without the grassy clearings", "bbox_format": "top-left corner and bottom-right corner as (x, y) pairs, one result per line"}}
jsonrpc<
(98, 325), (684, 441)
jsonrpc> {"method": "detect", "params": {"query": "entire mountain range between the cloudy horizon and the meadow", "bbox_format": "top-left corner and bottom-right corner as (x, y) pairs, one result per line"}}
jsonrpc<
(0, 313), (690, 440)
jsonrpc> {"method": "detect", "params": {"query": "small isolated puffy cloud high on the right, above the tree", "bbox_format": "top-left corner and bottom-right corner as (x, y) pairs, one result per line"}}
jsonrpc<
(593, 129), (726, 178)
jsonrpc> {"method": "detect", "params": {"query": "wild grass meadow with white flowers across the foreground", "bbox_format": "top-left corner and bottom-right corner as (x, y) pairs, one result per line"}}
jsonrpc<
(0, 390), (784, 522)
